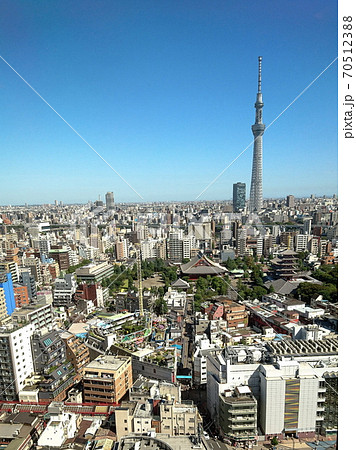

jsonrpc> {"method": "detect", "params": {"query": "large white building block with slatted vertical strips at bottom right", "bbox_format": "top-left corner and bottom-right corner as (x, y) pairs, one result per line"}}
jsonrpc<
(207, 346), (338, 438)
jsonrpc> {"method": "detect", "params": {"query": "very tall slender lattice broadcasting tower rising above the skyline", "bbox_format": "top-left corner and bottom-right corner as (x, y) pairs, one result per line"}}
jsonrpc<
(249, 56), (266, 213)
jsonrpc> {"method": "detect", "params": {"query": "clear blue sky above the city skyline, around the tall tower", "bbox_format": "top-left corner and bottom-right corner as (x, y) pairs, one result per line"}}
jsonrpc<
(0, 0), (338, 205)
